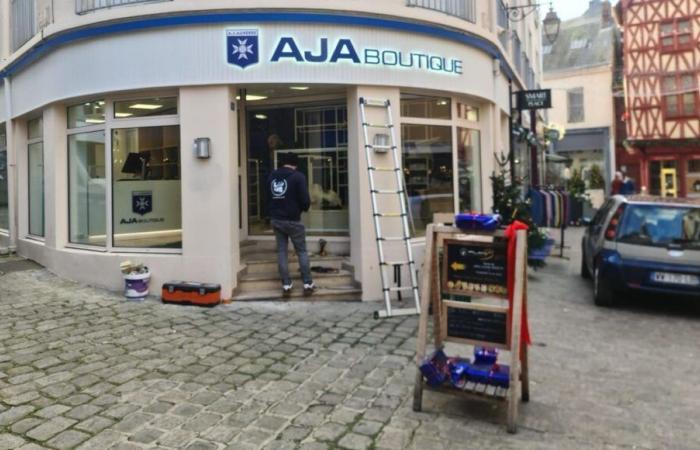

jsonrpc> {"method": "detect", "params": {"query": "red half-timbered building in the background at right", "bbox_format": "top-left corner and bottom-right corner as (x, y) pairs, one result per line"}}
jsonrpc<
(617, 0), (700, 197)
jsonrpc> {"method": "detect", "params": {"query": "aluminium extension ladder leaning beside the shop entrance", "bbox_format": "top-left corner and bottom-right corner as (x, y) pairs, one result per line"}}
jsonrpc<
(360, 97), (420, 319)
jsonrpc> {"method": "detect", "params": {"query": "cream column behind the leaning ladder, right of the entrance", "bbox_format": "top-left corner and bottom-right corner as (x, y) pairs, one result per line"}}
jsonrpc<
(348, 86), (400, 301)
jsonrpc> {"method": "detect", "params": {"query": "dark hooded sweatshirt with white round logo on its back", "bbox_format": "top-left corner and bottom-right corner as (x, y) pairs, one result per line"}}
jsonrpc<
(267, 167), (311, 222)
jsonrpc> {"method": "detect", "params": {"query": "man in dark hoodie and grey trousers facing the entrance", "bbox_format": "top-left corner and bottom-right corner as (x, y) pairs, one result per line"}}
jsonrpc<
(267, 153), (315, 295)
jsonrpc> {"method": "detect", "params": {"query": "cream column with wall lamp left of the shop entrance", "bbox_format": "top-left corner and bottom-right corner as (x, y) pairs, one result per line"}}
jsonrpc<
(180, 85), (239, 299)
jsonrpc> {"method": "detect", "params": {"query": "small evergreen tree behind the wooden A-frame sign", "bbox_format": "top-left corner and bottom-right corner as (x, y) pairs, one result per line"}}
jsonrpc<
(490, 155), (547, 264)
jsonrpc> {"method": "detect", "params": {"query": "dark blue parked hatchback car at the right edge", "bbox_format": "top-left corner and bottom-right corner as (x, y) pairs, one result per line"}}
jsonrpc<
(581, 195), (700, 306)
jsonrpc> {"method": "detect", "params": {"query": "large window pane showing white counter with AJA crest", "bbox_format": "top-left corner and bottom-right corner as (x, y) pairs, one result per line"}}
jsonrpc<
(112, 125), (182, 248)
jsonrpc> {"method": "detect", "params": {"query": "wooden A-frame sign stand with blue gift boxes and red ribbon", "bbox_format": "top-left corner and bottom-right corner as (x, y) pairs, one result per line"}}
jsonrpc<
(413, 224), (529, 433)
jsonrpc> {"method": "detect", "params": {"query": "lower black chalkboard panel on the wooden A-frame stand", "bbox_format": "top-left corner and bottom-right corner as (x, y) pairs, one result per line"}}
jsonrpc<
(445, 306), (508, 346)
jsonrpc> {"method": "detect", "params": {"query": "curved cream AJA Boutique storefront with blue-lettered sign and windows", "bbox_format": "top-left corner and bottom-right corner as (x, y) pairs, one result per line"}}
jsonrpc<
(0, 13), (510, 300)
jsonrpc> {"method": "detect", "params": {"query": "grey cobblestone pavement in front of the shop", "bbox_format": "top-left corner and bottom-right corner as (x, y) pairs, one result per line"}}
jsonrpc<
(0, 230), (700, 450)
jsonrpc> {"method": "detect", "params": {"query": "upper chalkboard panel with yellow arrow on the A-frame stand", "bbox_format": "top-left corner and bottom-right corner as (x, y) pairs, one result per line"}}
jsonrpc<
(442, 239), (508, 298)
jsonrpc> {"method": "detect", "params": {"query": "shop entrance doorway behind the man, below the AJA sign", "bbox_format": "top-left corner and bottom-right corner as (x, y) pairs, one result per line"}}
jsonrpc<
(241, 86), (349, 237)
